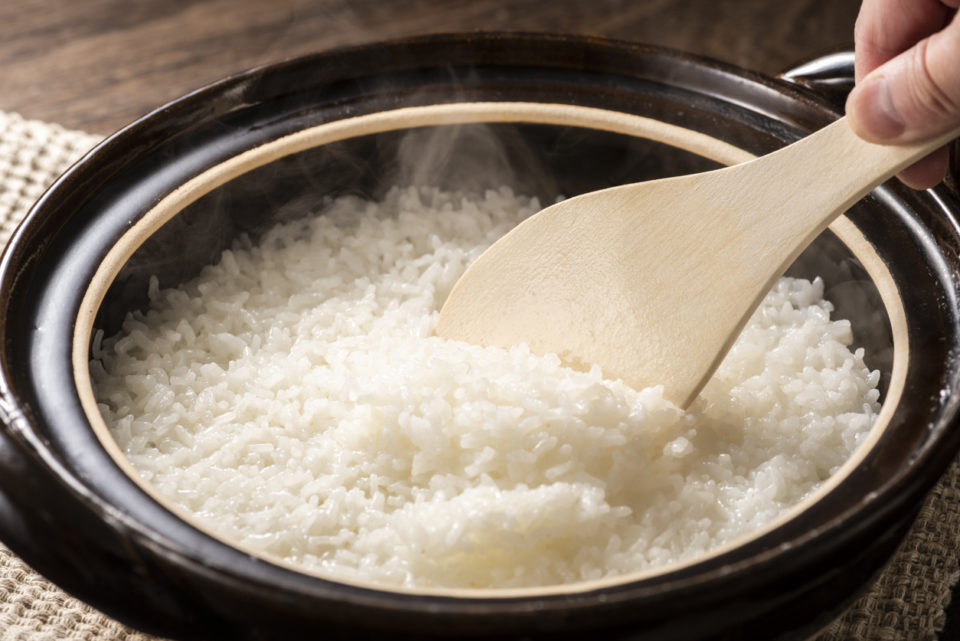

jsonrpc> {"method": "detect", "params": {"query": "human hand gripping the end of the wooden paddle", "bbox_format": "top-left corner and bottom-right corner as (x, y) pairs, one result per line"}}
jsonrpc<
(846, 0), (960, 189)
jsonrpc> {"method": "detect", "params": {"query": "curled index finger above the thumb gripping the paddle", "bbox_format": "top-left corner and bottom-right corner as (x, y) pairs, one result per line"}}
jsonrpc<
(854, 0), (960, 82)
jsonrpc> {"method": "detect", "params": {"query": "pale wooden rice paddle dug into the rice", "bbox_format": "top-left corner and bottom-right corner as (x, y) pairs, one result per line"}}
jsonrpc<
(436, 118), (960, 407)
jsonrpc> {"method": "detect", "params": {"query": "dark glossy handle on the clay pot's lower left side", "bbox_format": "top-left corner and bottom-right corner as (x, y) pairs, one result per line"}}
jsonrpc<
(0, 396), (210, 638)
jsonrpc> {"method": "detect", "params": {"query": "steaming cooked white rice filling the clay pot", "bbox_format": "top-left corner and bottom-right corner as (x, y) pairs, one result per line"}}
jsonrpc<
(91, 188), (879, 588)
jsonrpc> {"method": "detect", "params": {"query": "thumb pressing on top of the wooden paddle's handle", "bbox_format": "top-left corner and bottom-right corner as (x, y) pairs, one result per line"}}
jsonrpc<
(847, 15), (960, 144)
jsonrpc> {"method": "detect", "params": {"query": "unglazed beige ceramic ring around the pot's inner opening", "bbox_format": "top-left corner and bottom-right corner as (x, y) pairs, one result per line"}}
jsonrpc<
(72, 102), (908, 598)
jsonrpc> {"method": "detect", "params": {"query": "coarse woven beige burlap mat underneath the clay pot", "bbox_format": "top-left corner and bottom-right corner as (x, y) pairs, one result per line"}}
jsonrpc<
(0, 112), (960, 641)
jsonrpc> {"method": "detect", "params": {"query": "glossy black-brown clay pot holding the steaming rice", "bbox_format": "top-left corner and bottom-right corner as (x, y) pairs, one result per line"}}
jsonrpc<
(0, 34), (960, 640)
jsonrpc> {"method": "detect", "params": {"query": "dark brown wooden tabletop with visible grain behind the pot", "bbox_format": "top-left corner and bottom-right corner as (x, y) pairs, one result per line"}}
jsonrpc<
(0, 0), (960, 639)
